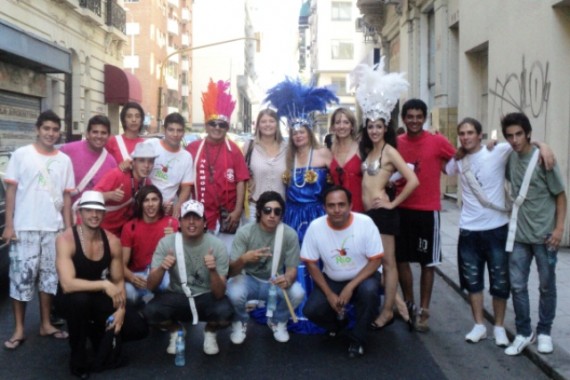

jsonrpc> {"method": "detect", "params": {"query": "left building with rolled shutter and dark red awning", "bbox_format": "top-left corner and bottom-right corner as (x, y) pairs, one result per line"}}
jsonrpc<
(0, 0), (131, 150)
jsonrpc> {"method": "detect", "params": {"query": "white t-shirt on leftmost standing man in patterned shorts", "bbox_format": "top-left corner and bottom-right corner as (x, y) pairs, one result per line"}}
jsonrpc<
(4, 144), (75, 231)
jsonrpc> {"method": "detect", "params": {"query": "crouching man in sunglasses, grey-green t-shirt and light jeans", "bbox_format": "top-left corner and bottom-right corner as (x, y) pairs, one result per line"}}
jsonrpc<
(227, 191), (305, 344)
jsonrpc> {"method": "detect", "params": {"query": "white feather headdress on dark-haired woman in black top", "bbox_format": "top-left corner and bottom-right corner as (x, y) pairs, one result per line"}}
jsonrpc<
(351, 57), (410, 124)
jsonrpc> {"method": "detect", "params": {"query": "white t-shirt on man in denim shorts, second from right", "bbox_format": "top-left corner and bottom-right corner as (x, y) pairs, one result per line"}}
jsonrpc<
(445, 143), (512, 231)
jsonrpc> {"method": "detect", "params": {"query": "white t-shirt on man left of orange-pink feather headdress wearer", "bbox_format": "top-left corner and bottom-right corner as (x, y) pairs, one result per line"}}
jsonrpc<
(149, 139), (194, 202)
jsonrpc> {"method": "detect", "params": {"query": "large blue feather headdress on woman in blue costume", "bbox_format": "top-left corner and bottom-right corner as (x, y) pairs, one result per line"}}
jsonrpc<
(265, 78), (338, 129)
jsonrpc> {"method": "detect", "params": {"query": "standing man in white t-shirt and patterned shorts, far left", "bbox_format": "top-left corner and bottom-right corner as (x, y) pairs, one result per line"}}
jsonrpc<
(2, 110), (75, 350)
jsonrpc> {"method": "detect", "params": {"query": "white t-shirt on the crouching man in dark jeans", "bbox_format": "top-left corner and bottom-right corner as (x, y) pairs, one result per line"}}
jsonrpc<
(301, 212), (384, 281)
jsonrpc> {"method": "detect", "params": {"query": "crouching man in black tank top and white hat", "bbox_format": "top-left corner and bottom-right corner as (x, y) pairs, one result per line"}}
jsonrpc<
(55, 191), (148, 377)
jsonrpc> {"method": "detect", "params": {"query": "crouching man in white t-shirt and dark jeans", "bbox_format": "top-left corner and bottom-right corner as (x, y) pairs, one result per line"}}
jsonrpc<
(301, 186), (384, 358)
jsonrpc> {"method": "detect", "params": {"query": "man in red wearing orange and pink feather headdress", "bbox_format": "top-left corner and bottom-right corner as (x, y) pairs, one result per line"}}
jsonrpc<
(187, 80), (249, 252)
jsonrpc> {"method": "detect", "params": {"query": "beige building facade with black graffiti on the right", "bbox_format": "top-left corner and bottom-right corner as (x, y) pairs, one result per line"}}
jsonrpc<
(357, 0), (570, 244)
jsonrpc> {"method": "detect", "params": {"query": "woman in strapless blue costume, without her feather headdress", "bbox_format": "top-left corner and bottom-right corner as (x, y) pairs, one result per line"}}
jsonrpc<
(283, 125), (332, 244)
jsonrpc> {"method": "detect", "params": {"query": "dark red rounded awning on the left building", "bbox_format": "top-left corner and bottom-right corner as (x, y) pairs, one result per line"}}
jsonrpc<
(105, 65), (142, 104)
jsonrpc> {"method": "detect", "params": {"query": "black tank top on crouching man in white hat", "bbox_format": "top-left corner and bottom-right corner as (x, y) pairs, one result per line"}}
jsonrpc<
(72, 227), (111, 281)
